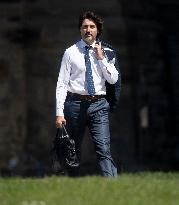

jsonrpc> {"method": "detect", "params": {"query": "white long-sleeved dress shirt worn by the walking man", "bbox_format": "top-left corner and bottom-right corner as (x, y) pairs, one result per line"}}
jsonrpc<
(56, 40), (118, 116)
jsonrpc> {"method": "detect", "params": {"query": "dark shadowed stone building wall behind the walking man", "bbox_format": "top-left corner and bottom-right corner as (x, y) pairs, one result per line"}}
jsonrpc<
(0, 0), (179, 174)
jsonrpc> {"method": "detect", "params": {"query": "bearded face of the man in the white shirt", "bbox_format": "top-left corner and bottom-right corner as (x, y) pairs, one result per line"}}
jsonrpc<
(80, 19), (98, 45)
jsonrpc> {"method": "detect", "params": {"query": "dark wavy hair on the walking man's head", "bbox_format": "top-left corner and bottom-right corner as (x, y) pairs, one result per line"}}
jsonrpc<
(78, 11), (103, 37)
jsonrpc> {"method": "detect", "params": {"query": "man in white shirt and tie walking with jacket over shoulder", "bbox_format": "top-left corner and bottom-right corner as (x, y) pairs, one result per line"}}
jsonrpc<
(56, 11), (120, 177)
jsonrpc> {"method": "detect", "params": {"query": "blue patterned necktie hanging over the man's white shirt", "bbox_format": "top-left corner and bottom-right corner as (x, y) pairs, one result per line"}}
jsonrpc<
(85, 46), (95, 96)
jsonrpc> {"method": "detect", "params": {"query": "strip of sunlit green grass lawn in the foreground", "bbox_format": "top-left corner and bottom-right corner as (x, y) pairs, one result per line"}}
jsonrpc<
(0, 172), (179, 205)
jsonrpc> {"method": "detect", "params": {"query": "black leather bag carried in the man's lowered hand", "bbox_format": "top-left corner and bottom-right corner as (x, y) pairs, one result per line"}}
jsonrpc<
(52, 124), (79, 172)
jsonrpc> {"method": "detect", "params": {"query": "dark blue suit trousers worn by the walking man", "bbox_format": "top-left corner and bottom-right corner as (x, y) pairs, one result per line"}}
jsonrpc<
(64, 96), (117, 177)
